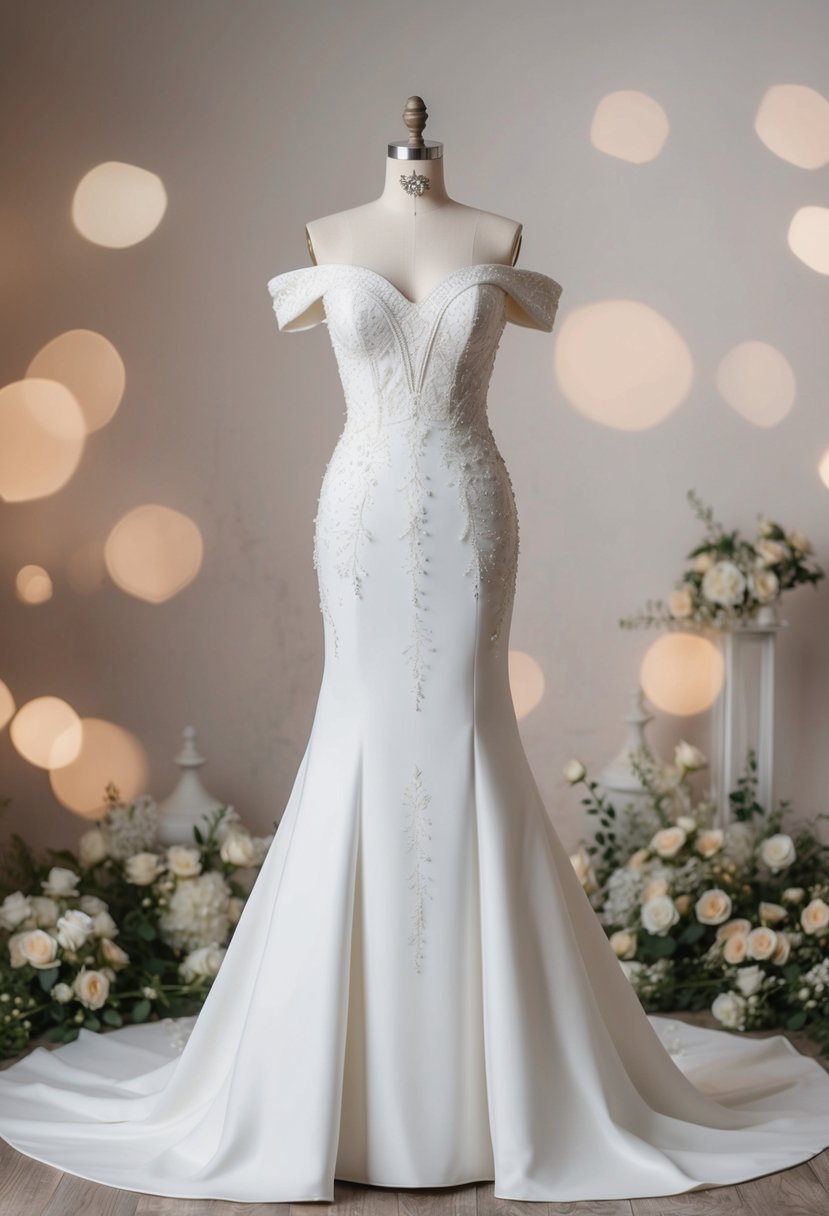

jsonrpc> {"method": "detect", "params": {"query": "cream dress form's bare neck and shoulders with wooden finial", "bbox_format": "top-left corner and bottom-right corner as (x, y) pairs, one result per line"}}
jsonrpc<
(305, 96), (521, 304)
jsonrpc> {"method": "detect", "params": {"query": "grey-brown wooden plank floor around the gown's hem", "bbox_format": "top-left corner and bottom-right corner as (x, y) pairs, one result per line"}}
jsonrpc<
(0, 1014), (829, 1216)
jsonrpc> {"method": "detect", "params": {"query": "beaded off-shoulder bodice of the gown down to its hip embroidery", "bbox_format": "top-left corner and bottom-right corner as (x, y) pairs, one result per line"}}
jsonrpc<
(267, 263), (562, 709)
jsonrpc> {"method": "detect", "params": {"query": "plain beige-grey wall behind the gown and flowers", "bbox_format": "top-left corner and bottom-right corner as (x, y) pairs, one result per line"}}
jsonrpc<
(0, 0), (829, 848)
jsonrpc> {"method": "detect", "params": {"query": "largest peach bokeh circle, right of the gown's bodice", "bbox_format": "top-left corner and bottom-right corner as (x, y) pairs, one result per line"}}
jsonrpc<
(556, 299), (693, 430)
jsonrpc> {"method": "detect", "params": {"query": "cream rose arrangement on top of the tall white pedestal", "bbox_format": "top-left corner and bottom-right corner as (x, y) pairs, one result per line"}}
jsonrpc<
(619, 490), (825, 629)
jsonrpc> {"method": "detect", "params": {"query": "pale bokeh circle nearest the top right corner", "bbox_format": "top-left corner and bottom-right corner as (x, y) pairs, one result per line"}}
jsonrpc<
(754, 84), (829, 169)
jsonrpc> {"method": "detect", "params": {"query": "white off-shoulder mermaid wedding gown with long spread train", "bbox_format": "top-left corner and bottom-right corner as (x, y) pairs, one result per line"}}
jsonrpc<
(0, 264), (829, 1201)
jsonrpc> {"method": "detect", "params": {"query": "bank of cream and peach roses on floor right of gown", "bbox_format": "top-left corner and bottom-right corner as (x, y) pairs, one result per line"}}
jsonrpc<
(564, 743), (829, 1053)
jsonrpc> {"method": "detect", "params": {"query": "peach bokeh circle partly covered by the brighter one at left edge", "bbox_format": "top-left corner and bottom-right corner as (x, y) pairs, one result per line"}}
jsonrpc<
(26, 330), (126, 432)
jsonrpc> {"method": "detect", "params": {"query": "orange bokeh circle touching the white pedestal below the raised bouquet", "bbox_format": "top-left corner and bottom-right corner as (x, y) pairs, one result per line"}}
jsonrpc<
(639, 630), (724, 715)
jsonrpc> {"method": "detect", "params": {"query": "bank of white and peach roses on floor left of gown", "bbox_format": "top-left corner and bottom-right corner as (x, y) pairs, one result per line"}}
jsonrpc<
(0, 784), (276, 1057)
